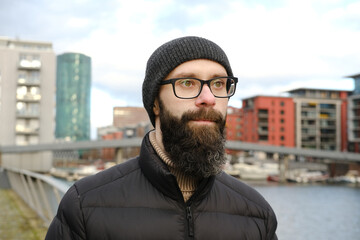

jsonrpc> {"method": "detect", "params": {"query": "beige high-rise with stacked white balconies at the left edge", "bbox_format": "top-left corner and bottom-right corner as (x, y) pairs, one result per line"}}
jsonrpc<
(0, 38), (56, 145)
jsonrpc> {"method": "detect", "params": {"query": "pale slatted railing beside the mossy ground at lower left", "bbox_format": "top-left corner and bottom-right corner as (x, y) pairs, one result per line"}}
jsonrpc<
(4, 168), (70, 225)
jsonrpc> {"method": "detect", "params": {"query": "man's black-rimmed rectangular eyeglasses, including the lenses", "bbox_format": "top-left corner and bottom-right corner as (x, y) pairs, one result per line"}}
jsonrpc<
(160, 77), (238, 99)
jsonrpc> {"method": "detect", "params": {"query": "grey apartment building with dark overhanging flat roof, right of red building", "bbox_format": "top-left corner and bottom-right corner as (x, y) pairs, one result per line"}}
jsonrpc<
(289, 88), (350, 151)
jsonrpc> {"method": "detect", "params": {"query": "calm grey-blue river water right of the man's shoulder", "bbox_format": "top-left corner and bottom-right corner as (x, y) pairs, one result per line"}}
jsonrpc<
(248, 183), (360, 240)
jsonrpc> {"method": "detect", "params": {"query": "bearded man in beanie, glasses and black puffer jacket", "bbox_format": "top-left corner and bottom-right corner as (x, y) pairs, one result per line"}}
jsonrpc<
(46, 37), (277, 240)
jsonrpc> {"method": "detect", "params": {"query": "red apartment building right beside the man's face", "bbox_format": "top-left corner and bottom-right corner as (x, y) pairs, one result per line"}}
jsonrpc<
(240, 96), (295, 147)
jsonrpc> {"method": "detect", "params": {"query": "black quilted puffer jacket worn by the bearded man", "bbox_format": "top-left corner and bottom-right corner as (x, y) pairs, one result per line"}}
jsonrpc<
(46, 135), (277, 240)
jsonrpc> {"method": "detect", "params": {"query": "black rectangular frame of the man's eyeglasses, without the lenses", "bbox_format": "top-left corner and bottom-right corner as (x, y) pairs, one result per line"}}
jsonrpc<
(160, 76), (238, 99)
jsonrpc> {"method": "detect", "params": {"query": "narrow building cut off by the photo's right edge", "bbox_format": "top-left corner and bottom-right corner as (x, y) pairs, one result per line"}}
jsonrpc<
(347, 74), (360, 152)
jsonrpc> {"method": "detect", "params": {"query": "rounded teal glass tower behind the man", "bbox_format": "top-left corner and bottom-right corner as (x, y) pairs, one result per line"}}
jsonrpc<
(55, 53), (91, 141)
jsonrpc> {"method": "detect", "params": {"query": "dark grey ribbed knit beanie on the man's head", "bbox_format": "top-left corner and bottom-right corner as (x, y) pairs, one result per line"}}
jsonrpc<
(142, 36), (233, 126)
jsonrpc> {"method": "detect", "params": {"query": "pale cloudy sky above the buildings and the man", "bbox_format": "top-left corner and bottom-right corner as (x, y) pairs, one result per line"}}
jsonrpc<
(0, 0), (360, 138)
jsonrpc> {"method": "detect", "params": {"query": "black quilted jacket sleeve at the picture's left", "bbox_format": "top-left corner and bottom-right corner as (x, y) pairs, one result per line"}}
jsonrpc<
(45, 186), (86, 240)
